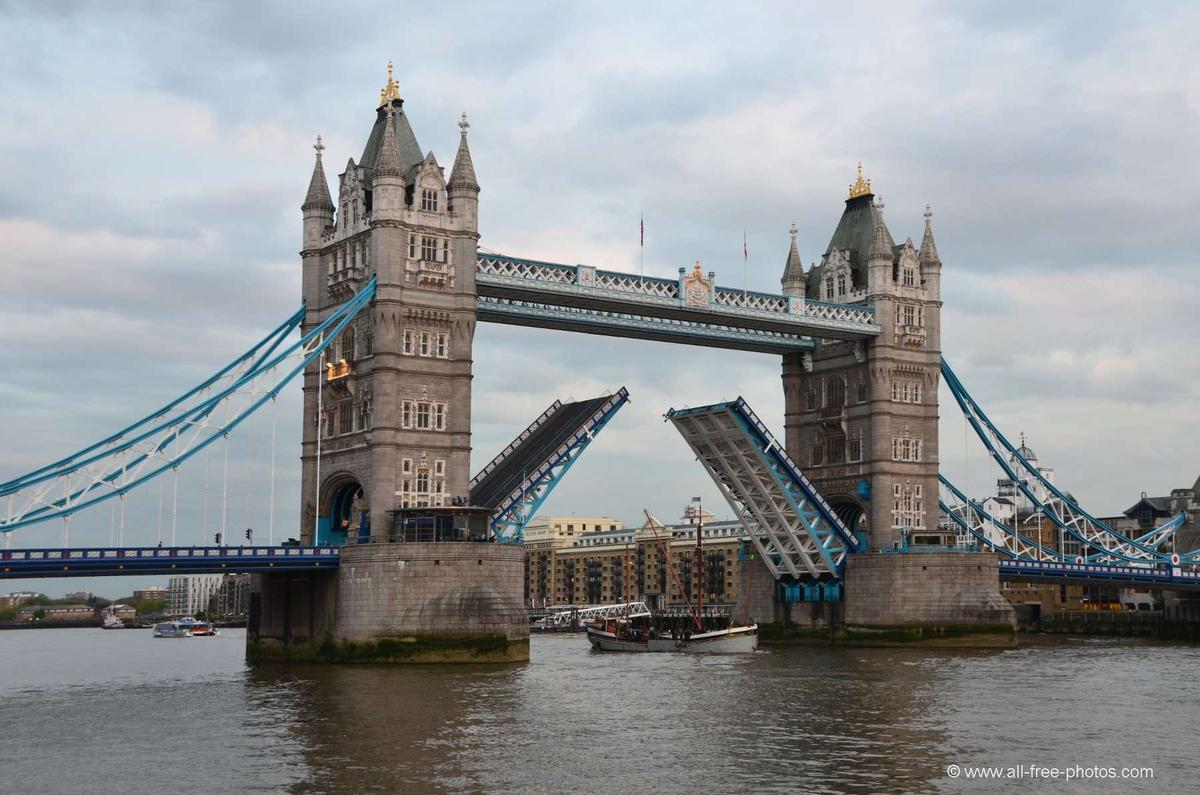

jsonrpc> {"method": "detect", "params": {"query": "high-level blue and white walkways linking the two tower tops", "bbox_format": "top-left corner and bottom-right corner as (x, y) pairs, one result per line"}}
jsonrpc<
(475, 255), (882, 353)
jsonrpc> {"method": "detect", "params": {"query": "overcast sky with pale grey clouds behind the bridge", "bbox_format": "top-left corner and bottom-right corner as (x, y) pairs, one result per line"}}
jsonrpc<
(0, 1), (1200, 596)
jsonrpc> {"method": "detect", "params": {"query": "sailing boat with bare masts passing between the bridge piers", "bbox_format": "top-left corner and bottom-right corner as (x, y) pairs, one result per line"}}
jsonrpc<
(584, 497), (758, 654)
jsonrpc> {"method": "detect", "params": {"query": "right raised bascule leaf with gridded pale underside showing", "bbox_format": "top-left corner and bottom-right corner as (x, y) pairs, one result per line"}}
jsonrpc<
(667, 398), (859, 580)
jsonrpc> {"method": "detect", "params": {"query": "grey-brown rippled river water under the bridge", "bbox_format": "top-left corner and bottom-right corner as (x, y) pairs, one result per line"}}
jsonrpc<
(0, 629), (1200, 794)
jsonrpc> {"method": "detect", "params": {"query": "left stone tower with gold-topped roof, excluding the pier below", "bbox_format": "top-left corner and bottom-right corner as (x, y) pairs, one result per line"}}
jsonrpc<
(301, 64), (479, 544)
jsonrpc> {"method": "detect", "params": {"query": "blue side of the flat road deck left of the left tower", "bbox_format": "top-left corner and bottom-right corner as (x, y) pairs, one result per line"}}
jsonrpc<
(0, 546), (341, 579)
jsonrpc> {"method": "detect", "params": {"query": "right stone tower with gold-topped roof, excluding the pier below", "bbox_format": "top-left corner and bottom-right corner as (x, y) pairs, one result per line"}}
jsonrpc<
(781, 165), (947, 549)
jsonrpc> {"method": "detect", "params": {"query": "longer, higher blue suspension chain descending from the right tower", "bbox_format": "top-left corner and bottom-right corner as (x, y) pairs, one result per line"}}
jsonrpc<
(942, 359), (1200, 563)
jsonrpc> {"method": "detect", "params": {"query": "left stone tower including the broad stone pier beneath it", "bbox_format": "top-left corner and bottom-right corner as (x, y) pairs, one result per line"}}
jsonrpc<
(246, 64), (529, 663)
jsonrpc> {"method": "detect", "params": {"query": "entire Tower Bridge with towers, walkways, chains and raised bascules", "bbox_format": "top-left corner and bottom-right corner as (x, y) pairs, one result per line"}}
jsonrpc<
(0, 65), (1200, 660)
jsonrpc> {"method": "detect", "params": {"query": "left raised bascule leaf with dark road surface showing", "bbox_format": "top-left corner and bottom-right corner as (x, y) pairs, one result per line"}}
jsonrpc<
(470, 387), (629, 544)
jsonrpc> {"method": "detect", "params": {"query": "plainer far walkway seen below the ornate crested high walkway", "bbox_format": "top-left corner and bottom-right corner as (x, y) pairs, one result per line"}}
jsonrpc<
(475, 295), (816, 354)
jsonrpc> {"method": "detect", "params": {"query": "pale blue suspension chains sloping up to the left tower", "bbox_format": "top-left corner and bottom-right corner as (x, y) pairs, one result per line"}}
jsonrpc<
(0, 277), (376, 532)
